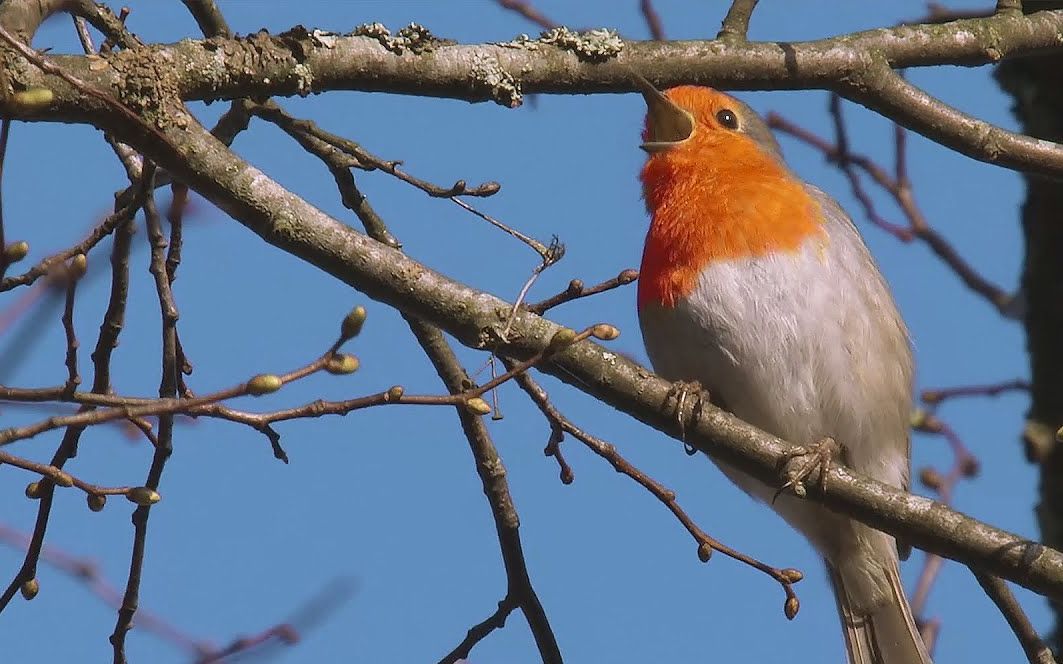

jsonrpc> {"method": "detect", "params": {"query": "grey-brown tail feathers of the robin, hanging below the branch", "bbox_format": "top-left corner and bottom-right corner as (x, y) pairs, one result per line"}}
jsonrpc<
(827, 563), (932, 664)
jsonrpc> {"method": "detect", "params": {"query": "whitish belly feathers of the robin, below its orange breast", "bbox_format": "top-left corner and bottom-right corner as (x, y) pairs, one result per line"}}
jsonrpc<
(639, 217), (912, 560)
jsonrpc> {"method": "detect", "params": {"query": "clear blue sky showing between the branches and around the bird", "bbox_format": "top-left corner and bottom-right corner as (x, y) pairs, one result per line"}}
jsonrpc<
(0, 0), (1033, 664)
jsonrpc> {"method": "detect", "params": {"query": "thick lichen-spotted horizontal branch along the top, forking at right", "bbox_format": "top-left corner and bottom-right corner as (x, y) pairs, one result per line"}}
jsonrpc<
(6, 11), (1063, 176)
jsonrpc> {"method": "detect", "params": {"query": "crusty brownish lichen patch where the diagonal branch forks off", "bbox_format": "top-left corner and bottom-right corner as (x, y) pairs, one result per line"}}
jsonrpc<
(107, 47), (181, 129)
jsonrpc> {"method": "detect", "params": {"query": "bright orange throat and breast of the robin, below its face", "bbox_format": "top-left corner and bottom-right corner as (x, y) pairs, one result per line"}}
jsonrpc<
(638, 140), (826, 308)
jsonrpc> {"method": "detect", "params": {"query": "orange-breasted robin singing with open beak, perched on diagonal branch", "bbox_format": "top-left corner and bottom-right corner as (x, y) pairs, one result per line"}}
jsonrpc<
(638, 81), (930, 664)
